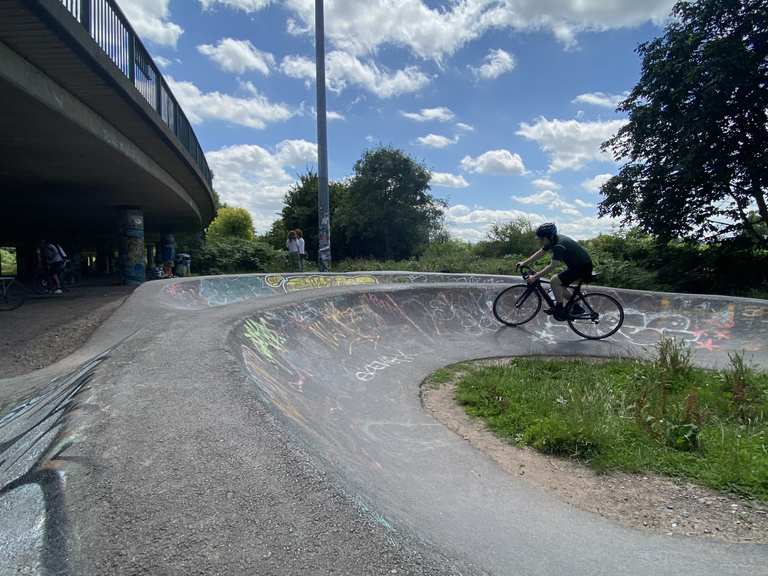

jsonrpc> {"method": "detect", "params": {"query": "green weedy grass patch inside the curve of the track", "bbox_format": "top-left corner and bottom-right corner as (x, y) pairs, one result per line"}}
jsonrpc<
(452, 340), (768, 501)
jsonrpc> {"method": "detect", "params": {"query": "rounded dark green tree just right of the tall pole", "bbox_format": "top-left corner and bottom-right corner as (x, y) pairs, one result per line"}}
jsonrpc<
(334, 147), (445, 260)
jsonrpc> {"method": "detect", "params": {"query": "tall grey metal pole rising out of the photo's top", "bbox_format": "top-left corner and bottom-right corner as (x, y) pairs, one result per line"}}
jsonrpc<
(315, 0), (331, 272)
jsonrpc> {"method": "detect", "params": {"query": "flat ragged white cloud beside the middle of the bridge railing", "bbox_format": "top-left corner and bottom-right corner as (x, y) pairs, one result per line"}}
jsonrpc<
(167, 77), (295, 129)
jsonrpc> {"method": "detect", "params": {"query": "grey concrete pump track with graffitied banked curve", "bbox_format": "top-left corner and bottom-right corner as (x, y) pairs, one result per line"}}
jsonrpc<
(0, 273), (768, 576)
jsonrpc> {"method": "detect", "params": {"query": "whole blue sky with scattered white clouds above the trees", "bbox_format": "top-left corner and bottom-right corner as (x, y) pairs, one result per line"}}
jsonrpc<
(119, 0), (673, 241)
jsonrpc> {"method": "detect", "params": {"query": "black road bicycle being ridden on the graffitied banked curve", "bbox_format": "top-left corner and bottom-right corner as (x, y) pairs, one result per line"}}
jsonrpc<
(493, 266), (624, 340)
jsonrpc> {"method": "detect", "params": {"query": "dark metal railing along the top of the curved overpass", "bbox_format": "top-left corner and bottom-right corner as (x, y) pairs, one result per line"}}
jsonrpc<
(61, 0), (213, 185)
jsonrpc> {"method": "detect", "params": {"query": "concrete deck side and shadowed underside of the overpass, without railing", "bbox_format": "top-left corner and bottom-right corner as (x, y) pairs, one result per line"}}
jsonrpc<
(0, 0), (214, 246)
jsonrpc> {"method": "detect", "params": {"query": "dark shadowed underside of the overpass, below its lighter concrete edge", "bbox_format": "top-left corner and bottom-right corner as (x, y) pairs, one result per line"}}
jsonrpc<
(0, 72), (200, 242)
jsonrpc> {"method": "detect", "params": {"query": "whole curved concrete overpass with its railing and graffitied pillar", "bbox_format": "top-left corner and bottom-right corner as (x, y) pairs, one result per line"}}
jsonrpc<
(0, 0), (215, 282)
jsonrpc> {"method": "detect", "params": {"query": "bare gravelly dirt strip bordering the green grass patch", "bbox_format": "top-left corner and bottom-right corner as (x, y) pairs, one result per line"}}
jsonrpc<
(422, 359), (768, 544)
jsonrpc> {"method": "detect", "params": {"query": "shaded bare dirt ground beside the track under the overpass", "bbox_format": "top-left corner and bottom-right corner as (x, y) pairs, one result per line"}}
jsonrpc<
(0, 286), (133, 379)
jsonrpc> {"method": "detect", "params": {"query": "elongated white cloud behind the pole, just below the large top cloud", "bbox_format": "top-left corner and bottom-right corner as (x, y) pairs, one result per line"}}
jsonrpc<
(280, 50), (431, 98)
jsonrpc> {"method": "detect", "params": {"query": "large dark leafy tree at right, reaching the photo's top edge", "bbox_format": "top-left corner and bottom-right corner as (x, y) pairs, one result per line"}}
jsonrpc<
(600, 0), (768, 245)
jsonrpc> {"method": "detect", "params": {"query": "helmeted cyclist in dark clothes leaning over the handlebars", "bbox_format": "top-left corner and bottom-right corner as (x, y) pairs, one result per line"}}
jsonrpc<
(517, 222), (592, 320)
